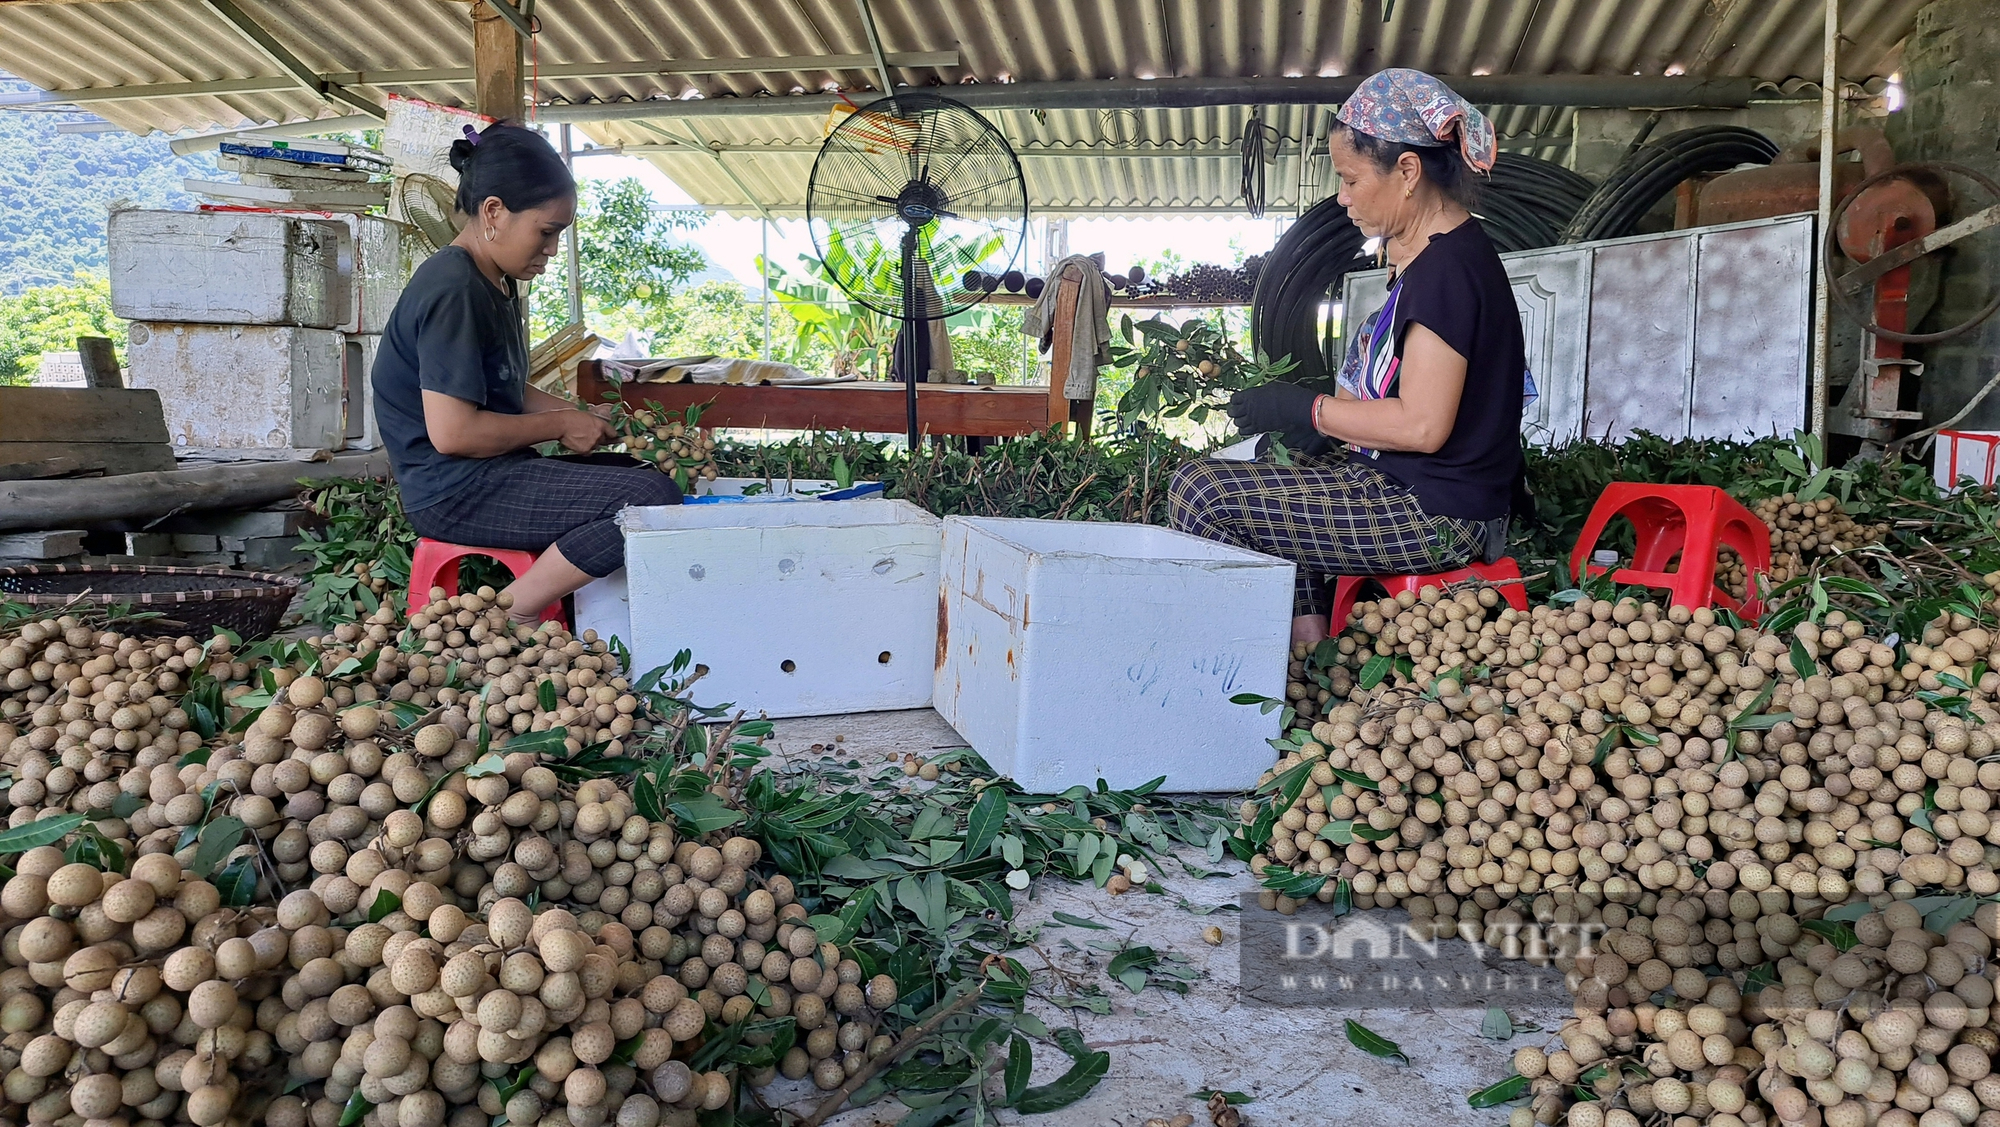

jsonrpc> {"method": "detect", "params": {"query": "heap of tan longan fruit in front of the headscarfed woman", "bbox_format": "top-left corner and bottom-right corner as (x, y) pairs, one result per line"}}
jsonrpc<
(1242, 587), (2000, 1127)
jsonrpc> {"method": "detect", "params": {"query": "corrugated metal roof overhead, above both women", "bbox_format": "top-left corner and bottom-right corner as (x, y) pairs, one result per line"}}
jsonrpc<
(0, 0), (1922, 210)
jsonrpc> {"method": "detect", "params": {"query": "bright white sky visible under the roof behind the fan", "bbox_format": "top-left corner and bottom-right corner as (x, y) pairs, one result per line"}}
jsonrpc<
(576, 154), (1280, 290)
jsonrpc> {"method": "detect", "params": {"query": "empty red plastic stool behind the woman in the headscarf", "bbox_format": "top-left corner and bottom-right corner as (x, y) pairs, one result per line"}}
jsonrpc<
(1570, 482), (1770, 617)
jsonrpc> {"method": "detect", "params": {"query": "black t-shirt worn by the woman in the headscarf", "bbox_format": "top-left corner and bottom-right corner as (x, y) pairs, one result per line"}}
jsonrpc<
(1376, 220), (1528, 520)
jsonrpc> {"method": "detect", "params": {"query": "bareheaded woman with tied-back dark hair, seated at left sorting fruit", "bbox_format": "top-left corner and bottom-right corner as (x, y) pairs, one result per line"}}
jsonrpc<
(372, 124), (680, 621)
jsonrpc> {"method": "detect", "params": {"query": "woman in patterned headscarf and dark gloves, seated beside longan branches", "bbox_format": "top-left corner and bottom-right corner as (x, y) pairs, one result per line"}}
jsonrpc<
(1170, 70), (1528, 643)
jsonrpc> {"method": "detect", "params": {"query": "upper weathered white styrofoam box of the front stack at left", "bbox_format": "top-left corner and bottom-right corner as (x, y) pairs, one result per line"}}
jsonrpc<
(110, 210), (354, 328)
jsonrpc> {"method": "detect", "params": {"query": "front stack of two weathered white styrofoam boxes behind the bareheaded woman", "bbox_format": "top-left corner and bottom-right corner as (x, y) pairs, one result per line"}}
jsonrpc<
(110, 210), (354, 450)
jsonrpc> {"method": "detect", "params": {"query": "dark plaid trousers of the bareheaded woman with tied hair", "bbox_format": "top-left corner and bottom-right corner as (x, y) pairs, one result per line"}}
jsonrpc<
(410, 454), (680, 577)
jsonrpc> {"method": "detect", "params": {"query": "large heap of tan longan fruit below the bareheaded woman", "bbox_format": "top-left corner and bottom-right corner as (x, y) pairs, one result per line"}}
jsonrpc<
(0, 607), (898, 1127)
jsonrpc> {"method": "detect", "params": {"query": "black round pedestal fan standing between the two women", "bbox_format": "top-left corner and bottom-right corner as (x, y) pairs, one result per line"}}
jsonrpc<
(806, 92), (1028, 450)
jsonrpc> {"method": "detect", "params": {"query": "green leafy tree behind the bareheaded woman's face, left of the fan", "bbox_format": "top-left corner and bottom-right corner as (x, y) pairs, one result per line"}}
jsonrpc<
(530, 176), (708, 340)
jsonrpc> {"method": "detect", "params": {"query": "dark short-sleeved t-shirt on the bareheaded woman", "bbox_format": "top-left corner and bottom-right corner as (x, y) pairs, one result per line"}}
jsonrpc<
(370, 246), (528, 512)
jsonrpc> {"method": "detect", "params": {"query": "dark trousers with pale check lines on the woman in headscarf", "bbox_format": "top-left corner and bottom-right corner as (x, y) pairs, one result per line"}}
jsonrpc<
(1168, 450), (1484, 615)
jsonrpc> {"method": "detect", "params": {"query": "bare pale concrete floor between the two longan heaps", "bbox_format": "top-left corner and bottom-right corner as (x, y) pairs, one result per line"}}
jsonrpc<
(766, 709), (1570, 1127)
